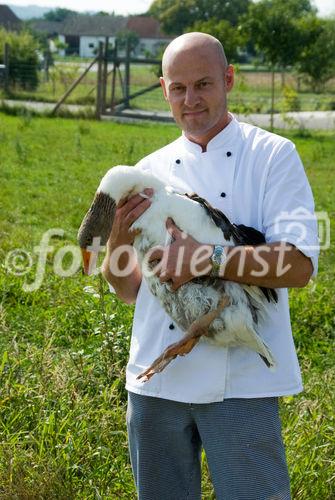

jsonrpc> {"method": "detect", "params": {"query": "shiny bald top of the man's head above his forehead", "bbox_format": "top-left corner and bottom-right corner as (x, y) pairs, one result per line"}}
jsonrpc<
(162, 32), (228, 76)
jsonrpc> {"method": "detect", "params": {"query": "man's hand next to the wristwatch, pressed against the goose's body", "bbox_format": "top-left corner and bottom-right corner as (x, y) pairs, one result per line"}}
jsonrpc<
(148, 219), (213, 291)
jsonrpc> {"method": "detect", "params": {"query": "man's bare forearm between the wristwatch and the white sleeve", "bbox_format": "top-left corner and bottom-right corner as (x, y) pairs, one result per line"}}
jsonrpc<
(222, 242), (313, 288)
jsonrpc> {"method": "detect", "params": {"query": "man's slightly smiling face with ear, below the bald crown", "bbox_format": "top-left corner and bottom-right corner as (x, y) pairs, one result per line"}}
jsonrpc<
(161, 50), (234, 145)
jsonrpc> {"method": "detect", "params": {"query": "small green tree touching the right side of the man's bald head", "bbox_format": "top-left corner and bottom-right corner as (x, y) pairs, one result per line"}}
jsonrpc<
(187, 18), (242, 62)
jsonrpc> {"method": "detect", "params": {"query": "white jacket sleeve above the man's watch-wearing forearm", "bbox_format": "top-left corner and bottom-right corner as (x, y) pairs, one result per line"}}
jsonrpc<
(263, 141), (319, 276)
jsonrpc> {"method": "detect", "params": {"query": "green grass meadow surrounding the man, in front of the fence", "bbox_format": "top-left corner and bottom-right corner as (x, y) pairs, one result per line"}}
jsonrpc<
(0, 114), (335, 500)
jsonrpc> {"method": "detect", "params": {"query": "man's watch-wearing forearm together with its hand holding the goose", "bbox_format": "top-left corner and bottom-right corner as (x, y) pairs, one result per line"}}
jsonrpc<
(149, 223), (313, 291)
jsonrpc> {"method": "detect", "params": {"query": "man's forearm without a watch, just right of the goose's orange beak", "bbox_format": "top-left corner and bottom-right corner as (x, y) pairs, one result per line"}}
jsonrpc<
(101, 247), (142, 304)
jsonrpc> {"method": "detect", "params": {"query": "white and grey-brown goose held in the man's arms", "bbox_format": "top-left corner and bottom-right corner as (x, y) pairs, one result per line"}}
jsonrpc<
(78, 165), (278, 382)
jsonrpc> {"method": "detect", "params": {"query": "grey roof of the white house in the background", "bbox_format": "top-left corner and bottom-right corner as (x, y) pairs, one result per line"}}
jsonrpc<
(58, 15), (127, 36)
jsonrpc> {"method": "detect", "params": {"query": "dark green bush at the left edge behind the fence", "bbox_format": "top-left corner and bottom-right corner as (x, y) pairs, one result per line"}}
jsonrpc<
(0, 30), (39, 90)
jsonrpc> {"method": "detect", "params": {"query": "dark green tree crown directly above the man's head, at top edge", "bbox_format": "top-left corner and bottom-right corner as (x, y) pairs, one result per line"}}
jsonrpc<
(148, 0), (251, 35)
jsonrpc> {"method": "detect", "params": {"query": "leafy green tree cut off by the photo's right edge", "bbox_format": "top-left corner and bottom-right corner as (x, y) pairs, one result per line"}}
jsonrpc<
(296, 16), (335, 91)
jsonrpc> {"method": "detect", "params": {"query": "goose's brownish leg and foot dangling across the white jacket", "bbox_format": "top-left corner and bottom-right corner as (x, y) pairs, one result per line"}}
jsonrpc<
(136, 296), (229, 382)
